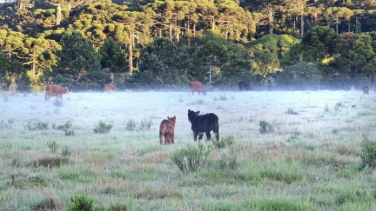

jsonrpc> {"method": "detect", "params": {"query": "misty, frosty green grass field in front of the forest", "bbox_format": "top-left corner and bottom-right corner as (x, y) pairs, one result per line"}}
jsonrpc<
(0, 91), (376, 211)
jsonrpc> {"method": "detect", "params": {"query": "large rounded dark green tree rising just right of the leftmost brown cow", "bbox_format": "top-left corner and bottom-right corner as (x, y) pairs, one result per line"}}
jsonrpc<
(54, 31), (109, 89)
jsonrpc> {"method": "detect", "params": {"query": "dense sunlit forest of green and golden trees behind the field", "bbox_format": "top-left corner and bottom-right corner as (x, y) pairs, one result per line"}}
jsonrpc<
(0, 0), (376, 91)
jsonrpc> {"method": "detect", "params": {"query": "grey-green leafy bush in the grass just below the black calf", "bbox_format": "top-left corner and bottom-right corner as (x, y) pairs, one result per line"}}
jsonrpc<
(171, 143), (213, 172)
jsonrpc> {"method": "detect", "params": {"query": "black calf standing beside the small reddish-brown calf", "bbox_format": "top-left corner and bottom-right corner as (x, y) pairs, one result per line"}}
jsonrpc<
(188, 109), (219, 141)
